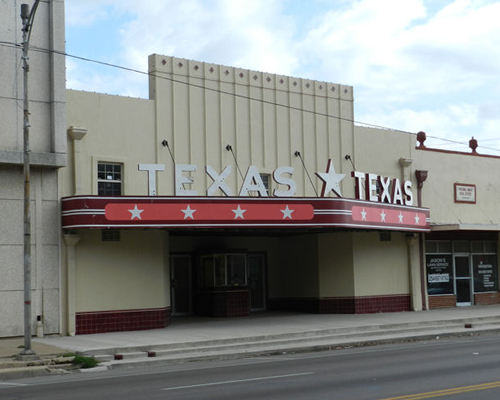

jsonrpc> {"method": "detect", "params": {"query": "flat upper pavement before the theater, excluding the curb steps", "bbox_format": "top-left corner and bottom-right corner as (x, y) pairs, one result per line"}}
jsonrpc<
(34, 304), (500, 352)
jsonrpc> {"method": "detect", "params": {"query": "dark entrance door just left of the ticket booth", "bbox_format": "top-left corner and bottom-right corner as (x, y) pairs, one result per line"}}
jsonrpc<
(170, 254), (192, 315)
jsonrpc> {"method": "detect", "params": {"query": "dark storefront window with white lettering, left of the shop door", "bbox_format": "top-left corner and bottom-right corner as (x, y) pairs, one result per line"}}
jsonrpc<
(426, 255), (453, 295)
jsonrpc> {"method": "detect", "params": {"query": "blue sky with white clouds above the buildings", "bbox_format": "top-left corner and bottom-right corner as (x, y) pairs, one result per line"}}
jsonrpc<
(65, 0), (500, 155)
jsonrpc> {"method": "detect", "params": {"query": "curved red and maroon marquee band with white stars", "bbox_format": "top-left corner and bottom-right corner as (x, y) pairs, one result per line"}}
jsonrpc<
(62, 196), (430, 232)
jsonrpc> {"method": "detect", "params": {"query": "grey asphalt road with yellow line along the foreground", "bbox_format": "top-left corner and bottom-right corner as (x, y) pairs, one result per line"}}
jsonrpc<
(0, 336), (500, 400)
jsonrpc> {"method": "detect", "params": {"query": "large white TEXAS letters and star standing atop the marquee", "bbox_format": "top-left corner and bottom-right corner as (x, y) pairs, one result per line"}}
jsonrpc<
(138, 160), (413, 206)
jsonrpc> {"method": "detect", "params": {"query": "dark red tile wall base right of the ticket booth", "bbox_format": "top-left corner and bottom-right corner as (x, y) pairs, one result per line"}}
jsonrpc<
(269, 294), (410, 314)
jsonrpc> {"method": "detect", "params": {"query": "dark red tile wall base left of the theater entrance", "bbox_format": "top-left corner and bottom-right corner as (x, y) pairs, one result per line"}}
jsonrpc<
(76, 307), (170, 335)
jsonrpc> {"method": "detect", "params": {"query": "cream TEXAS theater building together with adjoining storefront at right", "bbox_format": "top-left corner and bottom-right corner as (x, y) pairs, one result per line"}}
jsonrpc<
(59, 55), (500, 334)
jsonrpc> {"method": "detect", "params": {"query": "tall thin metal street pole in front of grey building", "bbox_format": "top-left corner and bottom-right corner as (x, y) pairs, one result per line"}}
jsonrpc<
(19, 0), (40, 359)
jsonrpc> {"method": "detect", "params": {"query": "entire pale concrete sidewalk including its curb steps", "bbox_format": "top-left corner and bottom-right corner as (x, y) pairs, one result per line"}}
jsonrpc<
(0, 304), (500, 380)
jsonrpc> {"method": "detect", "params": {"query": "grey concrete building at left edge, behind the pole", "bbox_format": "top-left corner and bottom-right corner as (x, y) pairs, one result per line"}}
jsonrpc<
(0, 0), (66, 336)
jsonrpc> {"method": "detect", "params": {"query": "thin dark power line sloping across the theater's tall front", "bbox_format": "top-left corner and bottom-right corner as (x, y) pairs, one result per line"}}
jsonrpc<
(0, 41), (500, 152)
